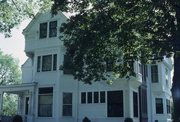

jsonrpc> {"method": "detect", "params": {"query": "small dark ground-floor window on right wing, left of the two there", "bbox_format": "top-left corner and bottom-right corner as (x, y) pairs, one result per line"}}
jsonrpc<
(156, 98), (163, 114)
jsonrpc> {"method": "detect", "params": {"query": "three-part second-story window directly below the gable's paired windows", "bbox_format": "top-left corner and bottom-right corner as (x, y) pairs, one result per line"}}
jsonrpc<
(37, 54), (57, 72)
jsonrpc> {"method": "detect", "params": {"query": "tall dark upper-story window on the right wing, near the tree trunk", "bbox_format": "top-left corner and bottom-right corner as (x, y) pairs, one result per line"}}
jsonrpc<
(151, 65), (159, 83)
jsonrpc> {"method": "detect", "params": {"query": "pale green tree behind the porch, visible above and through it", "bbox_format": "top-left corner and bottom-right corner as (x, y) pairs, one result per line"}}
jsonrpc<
(0, 51), (21, 116)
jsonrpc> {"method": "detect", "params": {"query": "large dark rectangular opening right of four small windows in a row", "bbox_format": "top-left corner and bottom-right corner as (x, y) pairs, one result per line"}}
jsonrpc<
(107, 91), (123, 117)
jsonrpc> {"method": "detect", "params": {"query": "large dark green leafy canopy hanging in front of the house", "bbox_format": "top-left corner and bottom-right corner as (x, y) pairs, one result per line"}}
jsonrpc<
(53, 0), (178, 83)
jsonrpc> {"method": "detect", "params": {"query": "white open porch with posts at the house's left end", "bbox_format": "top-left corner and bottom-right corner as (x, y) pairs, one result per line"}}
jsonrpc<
(0, 83), (36, 122)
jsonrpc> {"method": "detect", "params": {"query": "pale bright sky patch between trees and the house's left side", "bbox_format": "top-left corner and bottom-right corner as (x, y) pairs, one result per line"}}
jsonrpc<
(0, 20), (30, 66)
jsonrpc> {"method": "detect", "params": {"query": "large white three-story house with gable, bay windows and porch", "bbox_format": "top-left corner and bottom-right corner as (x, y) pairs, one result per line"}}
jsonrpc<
(0, 12), (173, 122)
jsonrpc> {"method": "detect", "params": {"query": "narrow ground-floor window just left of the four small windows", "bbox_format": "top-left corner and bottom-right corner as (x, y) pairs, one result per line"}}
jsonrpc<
(63, 93), (72, 116)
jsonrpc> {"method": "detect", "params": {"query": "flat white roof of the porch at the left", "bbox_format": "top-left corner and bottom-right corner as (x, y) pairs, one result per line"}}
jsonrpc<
(0, 82), (37, 94)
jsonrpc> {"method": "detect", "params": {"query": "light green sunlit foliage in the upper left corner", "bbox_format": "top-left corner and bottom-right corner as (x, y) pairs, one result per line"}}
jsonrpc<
(0, 0), (52, 37)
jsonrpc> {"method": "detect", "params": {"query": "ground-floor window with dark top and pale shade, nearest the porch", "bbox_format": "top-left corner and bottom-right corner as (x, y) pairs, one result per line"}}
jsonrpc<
(38, 87), (53, 117)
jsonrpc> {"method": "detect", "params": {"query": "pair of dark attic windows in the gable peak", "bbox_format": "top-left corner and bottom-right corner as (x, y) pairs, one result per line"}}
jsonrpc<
(39, 21), (57, 39)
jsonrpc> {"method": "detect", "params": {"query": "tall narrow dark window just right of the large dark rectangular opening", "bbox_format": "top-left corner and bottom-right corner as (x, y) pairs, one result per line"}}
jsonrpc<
(133, 92), (138, 117)
